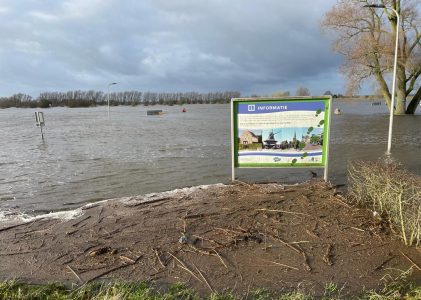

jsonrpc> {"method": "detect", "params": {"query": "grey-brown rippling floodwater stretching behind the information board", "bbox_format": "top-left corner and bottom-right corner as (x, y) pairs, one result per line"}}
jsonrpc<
(0, 100), (421, 218)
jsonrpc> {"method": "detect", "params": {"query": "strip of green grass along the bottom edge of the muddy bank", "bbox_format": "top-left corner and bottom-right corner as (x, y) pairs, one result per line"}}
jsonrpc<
(0, 276), (421, 300)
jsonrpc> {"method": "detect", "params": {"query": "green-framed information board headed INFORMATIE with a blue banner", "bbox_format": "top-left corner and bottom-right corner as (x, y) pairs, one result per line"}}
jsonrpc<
(231, 96), (331, 178)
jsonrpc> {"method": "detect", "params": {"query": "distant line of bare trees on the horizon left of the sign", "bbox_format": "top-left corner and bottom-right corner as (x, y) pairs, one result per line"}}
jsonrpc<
(0, 91), (240, 108)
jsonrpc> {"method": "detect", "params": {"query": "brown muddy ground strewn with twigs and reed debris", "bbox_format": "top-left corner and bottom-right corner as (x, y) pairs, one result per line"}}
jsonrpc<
(0, 182), (421, 295)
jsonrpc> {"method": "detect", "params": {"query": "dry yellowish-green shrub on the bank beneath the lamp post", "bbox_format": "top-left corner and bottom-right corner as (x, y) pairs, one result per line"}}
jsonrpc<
(348, 161), (421, 246)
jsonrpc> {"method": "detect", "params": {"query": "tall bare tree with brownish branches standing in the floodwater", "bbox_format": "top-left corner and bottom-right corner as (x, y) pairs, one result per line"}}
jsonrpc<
(322, 0), (421, 114)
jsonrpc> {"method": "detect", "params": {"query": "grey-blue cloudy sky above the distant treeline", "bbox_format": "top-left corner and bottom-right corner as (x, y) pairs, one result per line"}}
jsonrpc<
(0, 0), (344, 97)
